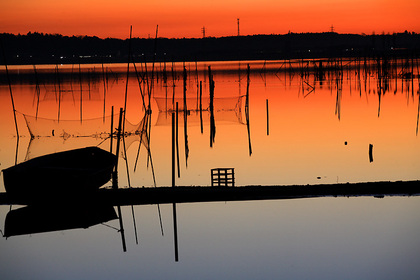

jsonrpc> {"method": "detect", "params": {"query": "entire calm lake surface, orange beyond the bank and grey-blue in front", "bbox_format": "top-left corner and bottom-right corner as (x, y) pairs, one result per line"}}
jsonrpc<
(0, 60), (420, 279)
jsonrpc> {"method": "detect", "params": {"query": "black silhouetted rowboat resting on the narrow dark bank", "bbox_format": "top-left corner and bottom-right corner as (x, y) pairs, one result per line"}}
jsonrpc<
(3, 147), (116, 198)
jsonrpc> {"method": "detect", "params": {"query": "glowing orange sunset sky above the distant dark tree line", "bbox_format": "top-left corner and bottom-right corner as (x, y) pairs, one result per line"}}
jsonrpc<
(0, 0), (420, 38)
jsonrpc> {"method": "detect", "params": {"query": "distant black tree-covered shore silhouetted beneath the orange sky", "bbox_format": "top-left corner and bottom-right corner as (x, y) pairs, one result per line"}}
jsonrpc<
(0, 31), (420, 64)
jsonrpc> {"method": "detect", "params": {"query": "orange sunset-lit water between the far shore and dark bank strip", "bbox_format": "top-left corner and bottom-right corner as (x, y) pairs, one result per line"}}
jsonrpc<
(0, 59), (420, 190)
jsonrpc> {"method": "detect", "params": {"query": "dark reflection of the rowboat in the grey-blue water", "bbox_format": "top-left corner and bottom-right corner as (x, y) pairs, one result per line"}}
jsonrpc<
(4, 204), (117, 238)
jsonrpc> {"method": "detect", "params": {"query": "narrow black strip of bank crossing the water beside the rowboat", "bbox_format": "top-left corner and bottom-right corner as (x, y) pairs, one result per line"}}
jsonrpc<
(0, 181), (420, 206)
